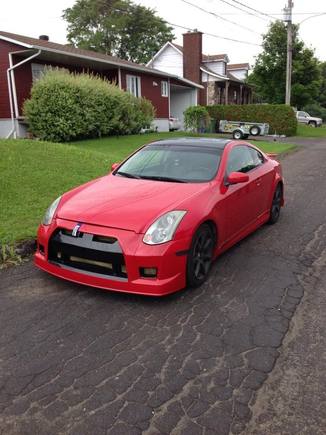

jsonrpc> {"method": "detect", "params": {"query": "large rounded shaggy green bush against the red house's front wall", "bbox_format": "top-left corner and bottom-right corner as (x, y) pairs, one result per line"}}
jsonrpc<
(24, 69), (154, 142)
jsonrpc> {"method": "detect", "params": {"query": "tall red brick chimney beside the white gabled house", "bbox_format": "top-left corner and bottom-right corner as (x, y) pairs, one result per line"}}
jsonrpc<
(183, 30), (203, 84)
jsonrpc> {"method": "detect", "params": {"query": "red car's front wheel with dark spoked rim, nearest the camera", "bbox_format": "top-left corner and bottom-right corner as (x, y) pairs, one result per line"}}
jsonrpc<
(186, 224), (216, 288)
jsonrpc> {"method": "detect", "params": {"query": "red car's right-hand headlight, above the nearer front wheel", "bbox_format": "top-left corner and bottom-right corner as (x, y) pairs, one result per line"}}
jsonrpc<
(143, 210), (187, 245)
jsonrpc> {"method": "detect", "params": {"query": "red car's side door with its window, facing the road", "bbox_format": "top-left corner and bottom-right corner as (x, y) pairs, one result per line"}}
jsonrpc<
(223, 145), (261, 242)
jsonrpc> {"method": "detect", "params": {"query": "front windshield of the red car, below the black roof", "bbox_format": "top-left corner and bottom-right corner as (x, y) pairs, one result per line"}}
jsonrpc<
(114, 144), (223, 183)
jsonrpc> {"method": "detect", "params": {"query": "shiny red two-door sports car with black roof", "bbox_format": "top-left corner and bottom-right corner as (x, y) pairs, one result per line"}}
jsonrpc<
(35, 138), (284, 296)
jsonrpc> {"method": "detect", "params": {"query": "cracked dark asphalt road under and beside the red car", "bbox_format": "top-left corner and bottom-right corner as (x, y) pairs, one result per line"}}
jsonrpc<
(0, 142), (326, 435)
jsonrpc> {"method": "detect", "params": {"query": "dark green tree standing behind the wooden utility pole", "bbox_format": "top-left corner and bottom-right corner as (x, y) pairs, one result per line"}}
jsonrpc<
(248, 20), (320, 108)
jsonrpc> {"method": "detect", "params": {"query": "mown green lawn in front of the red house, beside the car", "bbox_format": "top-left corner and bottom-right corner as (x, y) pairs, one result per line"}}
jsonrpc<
(0, 133), (294, 246)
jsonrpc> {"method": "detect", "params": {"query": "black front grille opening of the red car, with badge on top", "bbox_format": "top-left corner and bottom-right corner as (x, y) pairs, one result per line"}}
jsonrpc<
(48, 228), (127, 279)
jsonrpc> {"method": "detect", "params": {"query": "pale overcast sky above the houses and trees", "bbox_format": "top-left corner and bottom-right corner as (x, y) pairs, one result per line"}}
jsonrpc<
(0, 0), (326, 64)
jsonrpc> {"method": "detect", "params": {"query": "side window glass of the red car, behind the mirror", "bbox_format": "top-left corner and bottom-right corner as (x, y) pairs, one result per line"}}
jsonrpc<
(227, 145), (264, 174)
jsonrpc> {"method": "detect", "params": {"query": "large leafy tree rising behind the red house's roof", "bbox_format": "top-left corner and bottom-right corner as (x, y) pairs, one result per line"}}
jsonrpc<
(63, 0), (174, 63)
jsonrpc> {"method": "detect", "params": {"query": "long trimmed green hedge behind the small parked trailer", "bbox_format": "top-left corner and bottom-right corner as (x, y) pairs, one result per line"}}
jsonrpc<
(207, 104), (297, 136)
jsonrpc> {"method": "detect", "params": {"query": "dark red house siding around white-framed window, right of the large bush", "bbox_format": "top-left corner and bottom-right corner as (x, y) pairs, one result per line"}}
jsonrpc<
(121, 69), (169, 118)
